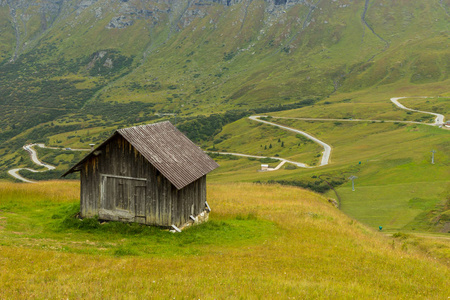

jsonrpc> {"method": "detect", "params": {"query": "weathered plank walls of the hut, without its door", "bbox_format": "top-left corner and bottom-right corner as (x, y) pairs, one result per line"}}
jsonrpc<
(80, 135), (206, 226)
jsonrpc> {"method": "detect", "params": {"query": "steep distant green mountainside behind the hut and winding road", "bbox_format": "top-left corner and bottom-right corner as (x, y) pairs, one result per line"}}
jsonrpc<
(0, 0), (450, 164)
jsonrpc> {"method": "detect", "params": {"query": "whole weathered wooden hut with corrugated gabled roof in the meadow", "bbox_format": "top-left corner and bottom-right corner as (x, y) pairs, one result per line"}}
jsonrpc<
(63, 121), (218, 227)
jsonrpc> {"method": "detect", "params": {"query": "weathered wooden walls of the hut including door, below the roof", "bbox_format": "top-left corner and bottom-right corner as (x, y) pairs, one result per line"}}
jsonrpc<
(81, 136), (206, 226)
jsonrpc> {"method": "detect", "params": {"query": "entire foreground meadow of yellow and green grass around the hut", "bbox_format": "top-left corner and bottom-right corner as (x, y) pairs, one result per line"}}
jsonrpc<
(0, 181), (450, 299)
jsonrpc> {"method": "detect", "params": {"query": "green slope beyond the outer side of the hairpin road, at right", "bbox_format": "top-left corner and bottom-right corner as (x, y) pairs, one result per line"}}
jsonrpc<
(264, 96), (450, 232)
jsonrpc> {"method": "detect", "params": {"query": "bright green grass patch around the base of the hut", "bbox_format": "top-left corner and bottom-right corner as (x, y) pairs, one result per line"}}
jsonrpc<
(0, 186), (279, 257)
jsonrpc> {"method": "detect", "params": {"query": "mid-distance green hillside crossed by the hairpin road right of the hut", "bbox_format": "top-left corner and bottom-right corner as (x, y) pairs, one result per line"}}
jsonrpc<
(198, 94), (450, 232)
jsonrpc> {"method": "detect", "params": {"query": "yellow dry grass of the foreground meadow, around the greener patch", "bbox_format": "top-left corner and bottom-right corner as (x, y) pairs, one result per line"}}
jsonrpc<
(0, 182), (450, 299)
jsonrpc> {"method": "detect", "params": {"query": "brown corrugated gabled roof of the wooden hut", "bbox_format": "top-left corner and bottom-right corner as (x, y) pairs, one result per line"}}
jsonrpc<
(63, 121), (219, 189)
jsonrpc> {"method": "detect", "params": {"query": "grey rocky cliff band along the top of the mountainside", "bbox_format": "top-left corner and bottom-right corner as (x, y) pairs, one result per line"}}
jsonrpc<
(0, 0), (311, 61)
